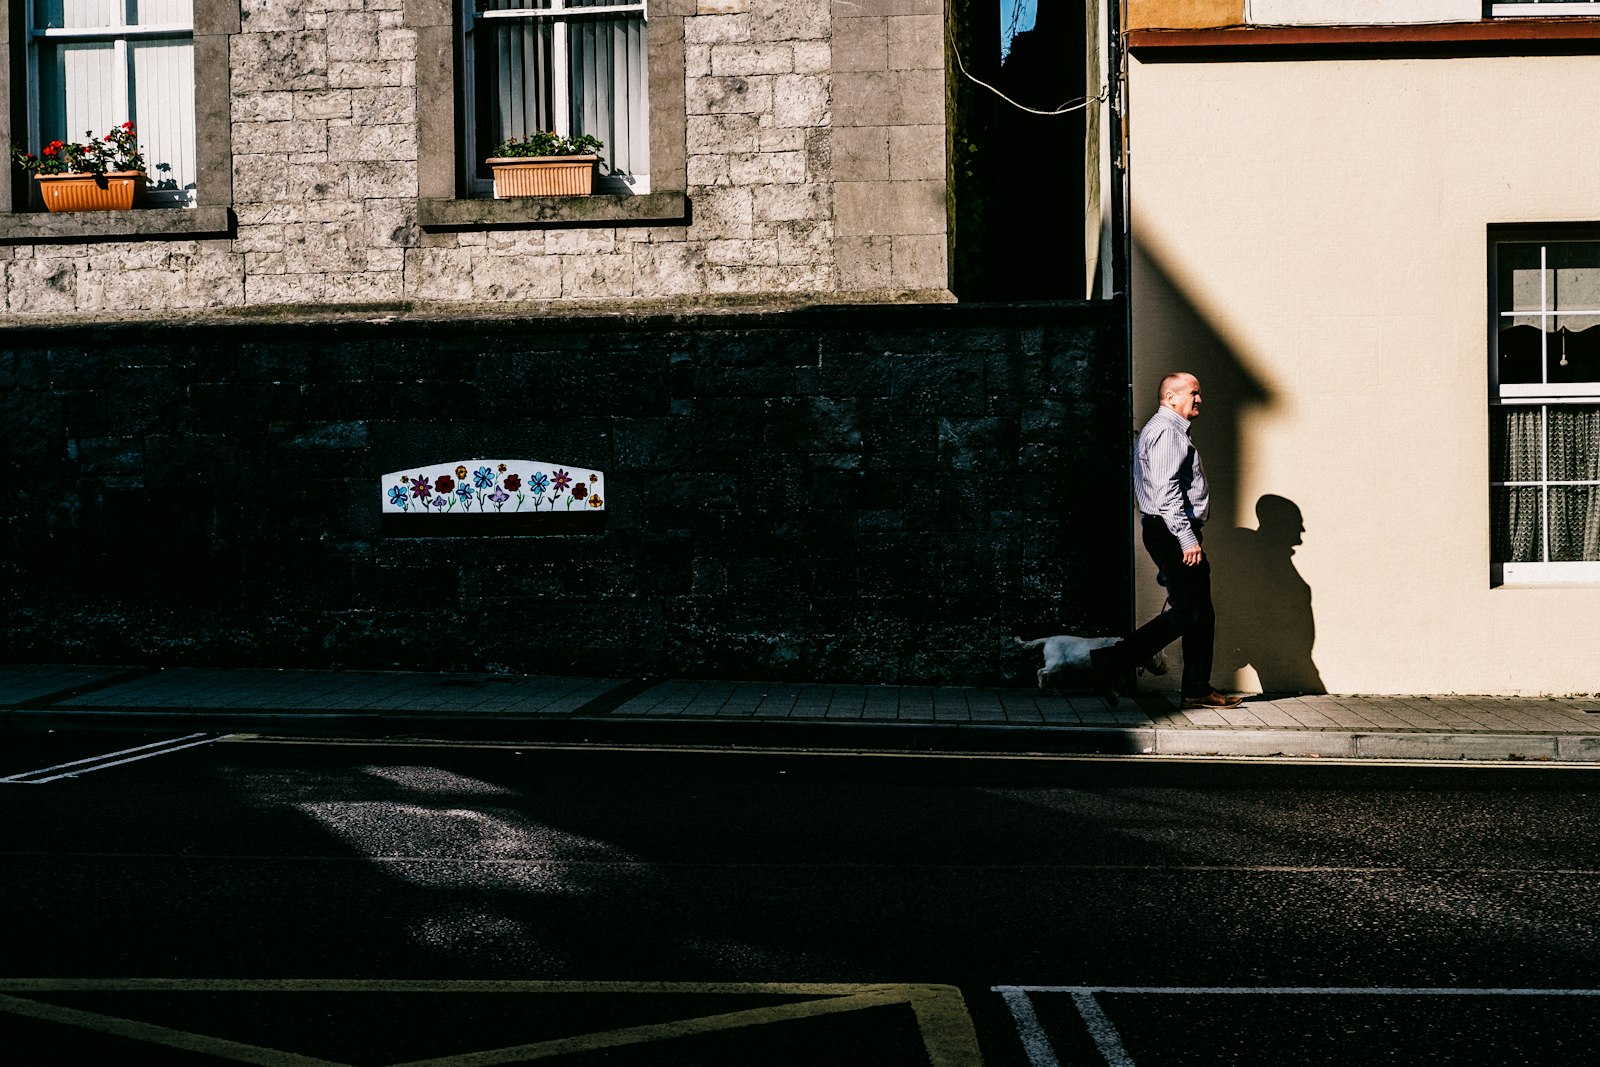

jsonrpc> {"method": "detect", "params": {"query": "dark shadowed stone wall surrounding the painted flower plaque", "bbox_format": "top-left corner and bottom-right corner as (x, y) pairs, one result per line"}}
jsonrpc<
(0, 304), (1130, 683)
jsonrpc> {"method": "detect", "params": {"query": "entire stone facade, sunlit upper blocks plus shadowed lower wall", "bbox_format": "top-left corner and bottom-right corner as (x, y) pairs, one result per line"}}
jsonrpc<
(0, 0), (1128, 683)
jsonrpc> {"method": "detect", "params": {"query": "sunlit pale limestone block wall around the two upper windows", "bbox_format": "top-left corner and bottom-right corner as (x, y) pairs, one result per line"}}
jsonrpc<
(0, 0), (950, 320)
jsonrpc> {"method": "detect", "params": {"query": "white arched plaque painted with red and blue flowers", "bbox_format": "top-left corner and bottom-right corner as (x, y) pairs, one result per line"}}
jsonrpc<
(382, 459), (605, 515)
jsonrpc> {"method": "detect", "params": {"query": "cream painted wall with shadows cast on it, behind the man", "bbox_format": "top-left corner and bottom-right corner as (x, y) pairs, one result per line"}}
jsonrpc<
(1130, 56), (1600, 694)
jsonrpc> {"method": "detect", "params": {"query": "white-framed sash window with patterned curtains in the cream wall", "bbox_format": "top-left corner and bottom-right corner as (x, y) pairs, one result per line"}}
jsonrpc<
(1490, 240), (1600, 584)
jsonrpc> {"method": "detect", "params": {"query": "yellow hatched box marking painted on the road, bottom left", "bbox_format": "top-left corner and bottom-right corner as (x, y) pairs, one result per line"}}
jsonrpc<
(0, 979), (982, 1067)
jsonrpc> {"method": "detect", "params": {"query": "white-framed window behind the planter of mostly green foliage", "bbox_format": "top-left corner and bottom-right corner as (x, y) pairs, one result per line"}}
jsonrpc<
(461, 0), (650, 195)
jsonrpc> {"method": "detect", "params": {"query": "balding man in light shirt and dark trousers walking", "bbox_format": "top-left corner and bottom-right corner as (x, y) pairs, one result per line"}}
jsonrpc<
(1090, 373), (1240, 710)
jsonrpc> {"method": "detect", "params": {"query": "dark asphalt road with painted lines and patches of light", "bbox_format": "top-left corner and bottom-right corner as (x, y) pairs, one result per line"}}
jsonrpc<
(0, 733), (1600, 1067)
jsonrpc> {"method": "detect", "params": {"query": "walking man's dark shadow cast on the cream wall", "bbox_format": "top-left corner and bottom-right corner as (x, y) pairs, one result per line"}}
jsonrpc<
(1206, 493), (1328, 693)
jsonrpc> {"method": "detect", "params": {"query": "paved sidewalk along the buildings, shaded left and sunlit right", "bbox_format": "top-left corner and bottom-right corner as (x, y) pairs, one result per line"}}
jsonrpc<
(0, 664), (1600, 763)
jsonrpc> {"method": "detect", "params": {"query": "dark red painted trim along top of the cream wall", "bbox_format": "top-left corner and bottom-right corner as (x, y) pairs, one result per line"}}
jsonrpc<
(1128, 16), (1600, 51)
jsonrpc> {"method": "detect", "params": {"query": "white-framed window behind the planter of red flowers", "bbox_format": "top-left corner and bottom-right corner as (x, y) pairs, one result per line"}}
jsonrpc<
(27, 0), (195, 206)
